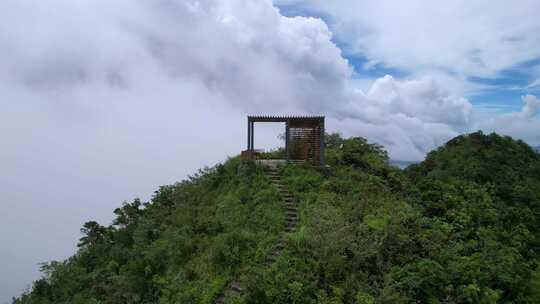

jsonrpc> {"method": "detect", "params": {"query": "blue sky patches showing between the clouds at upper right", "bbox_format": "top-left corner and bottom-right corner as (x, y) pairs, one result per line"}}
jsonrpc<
(276, 0), (540, 117)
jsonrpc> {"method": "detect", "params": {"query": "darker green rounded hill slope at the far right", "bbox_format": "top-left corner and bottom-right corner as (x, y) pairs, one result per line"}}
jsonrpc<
(407, 132), (540, 303)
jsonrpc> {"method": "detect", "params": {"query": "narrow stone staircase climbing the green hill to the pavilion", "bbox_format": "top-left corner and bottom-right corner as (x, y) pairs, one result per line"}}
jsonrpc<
(214, 165), (299, 304)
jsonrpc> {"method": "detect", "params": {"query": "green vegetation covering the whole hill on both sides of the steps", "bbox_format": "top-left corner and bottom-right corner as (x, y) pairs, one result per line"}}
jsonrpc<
(14, 132), (540, 304)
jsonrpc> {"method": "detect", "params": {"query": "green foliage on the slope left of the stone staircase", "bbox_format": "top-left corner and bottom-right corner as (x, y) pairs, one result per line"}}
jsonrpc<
(15, 158), (284, 304)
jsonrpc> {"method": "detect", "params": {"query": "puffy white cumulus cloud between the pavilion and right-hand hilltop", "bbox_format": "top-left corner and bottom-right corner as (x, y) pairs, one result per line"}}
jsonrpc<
(336, 75), (472, 160)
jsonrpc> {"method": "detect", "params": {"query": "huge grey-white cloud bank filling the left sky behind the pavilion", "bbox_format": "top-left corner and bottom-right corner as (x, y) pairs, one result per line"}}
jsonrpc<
(0, 0), (538, 301)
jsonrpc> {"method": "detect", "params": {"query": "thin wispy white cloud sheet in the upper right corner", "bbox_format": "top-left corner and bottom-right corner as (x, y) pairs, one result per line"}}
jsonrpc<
(275, 0), (540, 89)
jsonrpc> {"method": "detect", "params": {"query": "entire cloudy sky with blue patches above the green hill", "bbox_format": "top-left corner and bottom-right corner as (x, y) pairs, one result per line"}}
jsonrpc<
(0, 0), (540, 303)
